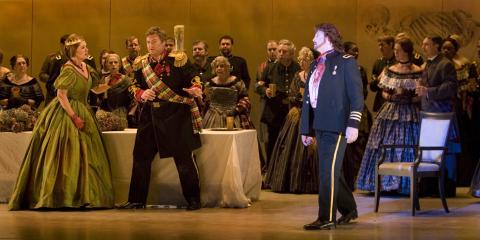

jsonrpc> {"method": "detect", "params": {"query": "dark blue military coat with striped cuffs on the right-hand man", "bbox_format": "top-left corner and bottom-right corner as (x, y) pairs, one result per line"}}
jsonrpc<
(300, 51), (364, 136)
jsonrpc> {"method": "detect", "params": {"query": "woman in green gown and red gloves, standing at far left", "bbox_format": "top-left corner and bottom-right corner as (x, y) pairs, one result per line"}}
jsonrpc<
(8, 34), (114, 210)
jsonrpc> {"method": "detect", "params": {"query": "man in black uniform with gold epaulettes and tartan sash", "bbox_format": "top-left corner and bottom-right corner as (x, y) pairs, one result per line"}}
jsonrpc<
(119, 27), (202, 210)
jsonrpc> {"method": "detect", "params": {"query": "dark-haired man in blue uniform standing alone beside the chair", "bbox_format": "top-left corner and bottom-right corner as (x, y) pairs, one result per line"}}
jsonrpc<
(300, 23), (363, 230)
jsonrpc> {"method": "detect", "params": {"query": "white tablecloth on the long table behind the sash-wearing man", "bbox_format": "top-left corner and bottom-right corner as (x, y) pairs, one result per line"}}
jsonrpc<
(0, 129), (262, 207)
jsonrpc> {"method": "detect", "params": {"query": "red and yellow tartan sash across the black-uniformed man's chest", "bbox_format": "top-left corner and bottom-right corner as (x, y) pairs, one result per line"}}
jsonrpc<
(142, 59), (202, 134)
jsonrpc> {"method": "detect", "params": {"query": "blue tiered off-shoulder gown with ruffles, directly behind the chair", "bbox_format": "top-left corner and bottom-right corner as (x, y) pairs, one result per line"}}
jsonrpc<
(357, 69), (422, 194)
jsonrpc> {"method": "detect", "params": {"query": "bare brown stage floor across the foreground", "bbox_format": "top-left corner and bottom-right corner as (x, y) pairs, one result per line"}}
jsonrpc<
(0, 188), (480, 240)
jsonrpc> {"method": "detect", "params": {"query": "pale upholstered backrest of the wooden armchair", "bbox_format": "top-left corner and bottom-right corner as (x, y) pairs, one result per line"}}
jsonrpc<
(418, 112), (453, 162)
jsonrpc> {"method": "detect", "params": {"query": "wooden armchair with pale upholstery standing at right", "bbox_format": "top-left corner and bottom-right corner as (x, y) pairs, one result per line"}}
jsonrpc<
(375, 112), (453, 216)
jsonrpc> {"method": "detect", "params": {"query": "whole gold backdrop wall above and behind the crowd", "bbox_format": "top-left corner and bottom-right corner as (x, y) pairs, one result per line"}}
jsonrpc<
(0, 0), (480, 117)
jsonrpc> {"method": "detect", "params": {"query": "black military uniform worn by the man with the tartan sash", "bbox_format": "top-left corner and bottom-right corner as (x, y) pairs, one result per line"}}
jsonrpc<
(121, 52), (201, 210)
